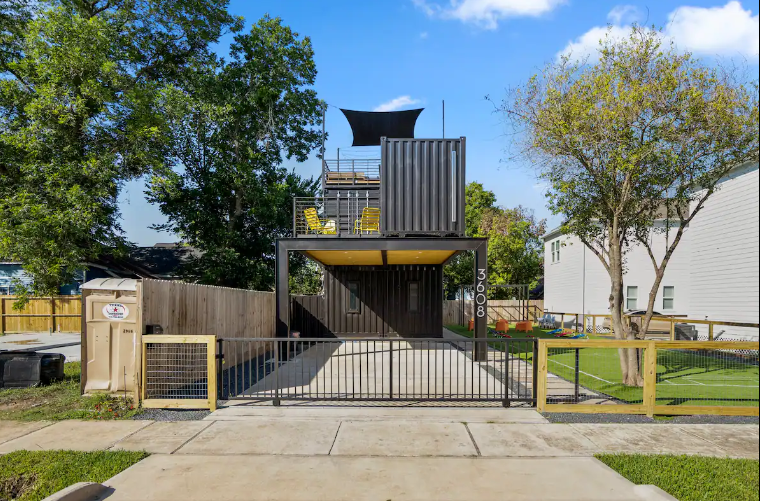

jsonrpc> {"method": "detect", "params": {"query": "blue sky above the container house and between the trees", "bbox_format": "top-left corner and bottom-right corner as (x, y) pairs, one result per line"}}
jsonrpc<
(120, 0), (760, 245)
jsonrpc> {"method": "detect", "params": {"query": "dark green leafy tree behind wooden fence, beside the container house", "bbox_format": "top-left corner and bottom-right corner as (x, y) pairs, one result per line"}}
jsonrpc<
(149, 16), (323, 289)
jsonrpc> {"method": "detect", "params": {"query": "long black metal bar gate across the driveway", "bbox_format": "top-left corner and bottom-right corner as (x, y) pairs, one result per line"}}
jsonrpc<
(218, 338), (538, 407)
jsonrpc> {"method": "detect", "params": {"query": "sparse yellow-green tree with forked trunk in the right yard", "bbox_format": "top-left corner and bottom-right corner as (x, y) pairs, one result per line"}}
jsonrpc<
(500, 27), (758, 385)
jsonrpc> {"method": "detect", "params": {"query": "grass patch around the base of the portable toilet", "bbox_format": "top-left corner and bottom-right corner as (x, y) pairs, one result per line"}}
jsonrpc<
(0, 362), (138, 420)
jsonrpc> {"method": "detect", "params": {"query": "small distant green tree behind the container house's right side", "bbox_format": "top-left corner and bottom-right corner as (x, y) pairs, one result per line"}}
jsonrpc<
(443, 182), (546, 299)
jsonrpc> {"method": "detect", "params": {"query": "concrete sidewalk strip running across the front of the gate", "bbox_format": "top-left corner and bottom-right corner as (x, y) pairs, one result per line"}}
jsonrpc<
(0, 407), (760, 459)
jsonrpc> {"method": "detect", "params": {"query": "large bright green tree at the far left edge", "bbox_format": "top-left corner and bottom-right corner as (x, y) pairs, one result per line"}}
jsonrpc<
(0, 0), (239, 294)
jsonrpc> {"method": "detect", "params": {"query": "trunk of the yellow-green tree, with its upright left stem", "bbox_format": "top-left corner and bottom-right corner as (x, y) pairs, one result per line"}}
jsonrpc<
(609, 231), (644, 386)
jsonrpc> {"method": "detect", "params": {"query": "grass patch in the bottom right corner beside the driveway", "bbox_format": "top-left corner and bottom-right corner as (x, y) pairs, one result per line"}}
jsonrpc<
(596, 454), (760, 501)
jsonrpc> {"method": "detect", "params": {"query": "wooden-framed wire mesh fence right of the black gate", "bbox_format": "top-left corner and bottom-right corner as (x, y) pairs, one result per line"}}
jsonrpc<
(537, 339), (760, 417)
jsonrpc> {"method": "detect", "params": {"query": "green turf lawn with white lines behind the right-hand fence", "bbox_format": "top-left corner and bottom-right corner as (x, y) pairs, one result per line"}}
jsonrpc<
(446, 325), (760, 406)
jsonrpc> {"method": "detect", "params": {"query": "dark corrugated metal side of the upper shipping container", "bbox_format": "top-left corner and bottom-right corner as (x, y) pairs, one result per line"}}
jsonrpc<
(380, 138), (466, 236)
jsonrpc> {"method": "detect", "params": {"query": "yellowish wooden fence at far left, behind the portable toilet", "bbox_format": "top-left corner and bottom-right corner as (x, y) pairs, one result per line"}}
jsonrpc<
(0, 296), (82, 336)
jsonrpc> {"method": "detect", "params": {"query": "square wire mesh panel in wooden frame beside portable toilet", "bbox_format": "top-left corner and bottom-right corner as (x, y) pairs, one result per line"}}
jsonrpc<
(142, 335), (217, 409)
